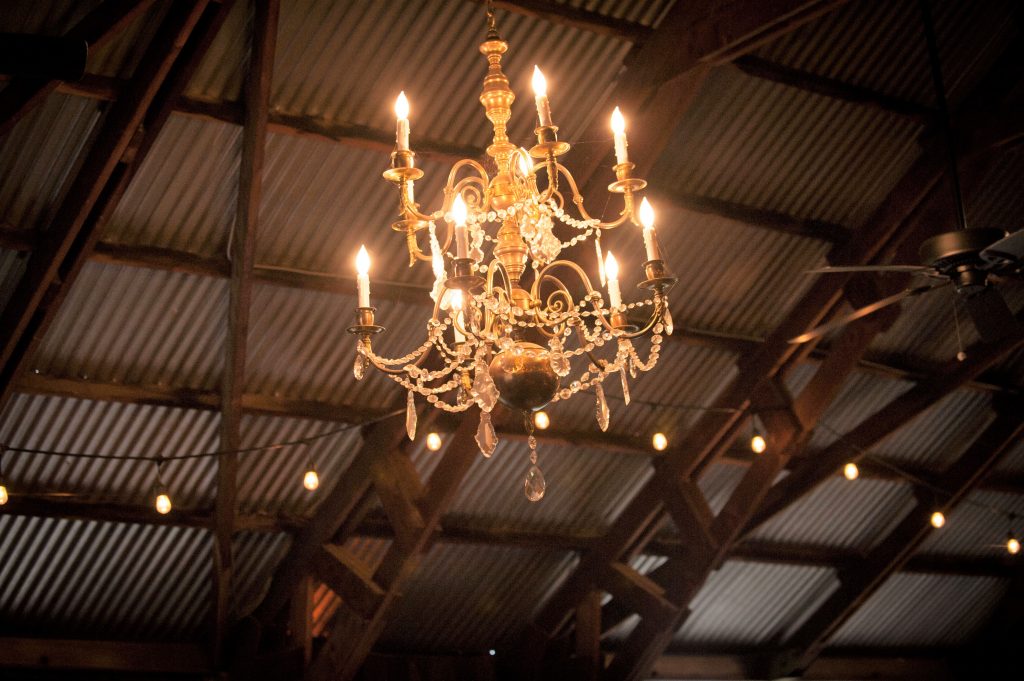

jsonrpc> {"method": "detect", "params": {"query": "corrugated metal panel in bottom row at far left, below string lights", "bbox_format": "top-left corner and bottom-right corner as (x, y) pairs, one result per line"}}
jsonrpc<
(0, 515), (211, 640)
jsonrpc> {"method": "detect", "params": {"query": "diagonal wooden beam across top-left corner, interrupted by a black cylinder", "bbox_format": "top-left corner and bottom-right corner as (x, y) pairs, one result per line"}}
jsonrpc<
(0, 0), (153, 137)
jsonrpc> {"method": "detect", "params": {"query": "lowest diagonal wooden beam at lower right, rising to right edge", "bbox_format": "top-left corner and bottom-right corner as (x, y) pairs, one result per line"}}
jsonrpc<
(768, 400), (1024, 678)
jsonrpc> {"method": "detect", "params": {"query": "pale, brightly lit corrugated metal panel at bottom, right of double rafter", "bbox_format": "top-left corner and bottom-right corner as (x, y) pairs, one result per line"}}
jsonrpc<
(673, 562), (839, 646)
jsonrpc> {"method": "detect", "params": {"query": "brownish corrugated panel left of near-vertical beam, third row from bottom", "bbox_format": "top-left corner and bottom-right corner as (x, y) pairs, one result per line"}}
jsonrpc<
(30, 263), (227, 389)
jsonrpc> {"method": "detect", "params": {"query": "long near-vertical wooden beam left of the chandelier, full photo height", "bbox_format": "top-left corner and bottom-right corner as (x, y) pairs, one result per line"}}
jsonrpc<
(213, 0), (280, 666)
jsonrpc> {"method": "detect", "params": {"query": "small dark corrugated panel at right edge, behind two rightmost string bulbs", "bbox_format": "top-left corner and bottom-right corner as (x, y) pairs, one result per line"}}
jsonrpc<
(921, 490), (1024, 556)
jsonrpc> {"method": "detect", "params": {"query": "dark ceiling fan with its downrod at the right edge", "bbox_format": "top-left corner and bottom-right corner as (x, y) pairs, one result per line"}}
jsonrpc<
(790, 0), (1024, 346)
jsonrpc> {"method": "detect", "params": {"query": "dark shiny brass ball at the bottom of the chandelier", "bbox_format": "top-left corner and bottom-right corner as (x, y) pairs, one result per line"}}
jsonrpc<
(488, 341), (558, 412)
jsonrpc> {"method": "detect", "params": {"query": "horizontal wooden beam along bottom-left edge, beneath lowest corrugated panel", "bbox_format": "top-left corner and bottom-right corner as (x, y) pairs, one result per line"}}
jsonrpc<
(0, 638), (212, 675)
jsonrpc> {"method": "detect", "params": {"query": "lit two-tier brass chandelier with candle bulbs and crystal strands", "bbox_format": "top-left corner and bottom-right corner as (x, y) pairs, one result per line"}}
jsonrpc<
(348, 9), (676, 501)
